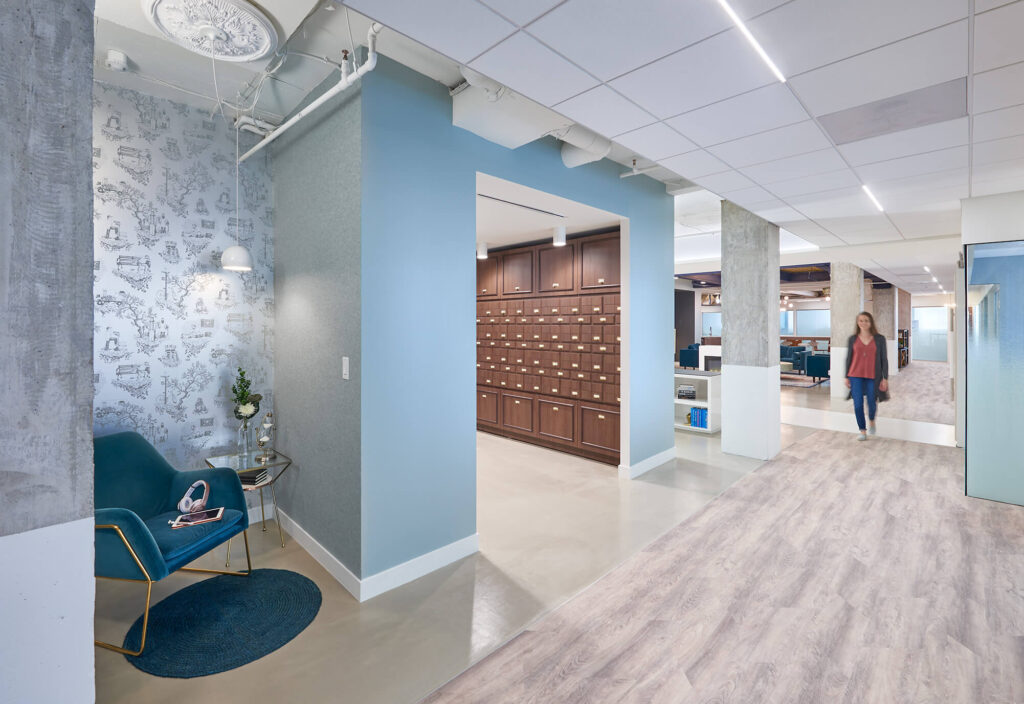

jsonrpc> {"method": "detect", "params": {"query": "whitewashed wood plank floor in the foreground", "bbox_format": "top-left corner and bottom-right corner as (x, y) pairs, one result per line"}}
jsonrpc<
(426, 431), (1024, 704)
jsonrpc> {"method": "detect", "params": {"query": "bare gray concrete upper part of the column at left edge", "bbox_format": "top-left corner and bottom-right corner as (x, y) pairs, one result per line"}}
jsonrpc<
(0, 0), (93, 532)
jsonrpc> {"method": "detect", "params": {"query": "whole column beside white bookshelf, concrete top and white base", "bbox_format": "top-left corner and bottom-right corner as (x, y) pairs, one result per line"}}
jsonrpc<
(722, 201), (781, 459)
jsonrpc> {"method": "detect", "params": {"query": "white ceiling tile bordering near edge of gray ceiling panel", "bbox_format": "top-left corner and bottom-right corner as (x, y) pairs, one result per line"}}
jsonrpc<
(790, 20), (967, 115)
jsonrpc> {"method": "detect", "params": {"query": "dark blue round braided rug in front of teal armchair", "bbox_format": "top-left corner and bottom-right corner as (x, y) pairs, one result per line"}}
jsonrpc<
(124, 570), (322, 677)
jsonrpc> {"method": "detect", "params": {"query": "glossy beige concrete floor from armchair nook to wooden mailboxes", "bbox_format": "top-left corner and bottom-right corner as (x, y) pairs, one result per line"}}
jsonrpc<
(96, 427), (813, 704)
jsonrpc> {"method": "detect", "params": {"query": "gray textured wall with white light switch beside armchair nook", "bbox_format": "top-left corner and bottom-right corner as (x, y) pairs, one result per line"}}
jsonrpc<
(270, 88), (364, 576)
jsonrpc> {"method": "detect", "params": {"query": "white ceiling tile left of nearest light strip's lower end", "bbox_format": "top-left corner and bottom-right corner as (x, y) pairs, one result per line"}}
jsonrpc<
(610, 28), (775, 119)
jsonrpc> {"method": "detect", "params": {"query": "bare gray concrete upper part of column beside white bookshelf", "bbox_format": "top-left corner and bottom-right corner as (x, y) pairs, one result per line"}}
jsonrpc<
(722, 201), (779, 366)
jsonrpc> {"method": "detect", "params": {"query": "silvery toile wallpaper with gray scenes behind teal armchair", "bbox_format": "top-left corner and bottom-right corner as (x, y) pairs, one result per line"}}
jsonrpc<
(92, 83), (273, 470)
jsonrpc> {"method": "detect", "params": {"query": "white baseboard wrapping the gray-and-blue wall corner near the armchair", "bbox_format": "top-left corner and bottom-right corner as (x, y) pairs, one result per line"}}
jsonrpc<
(272, 507), (480, 602)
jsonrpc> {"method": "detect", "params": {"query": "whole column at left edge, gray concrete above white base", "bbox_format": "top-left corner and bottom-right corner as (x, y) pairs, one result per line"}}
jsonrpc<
(0, 0), (96, 702)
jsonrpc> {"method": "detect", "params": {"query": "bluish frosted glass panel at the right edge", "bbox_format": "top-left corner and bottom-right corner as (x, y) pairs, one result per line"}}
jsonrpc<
(967, 241), (1024, 505)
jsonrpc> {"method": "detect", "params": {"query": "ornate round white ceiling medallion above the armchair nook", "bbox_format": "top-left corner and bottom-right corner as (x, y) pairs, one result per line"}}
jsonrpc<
(142, 0), (278, 61)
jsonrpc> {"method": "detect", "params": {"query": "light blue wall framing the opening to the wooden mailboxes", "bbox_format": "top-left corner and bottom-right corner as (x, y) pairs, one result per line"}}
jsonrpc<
(361, 57), (674, 575)
